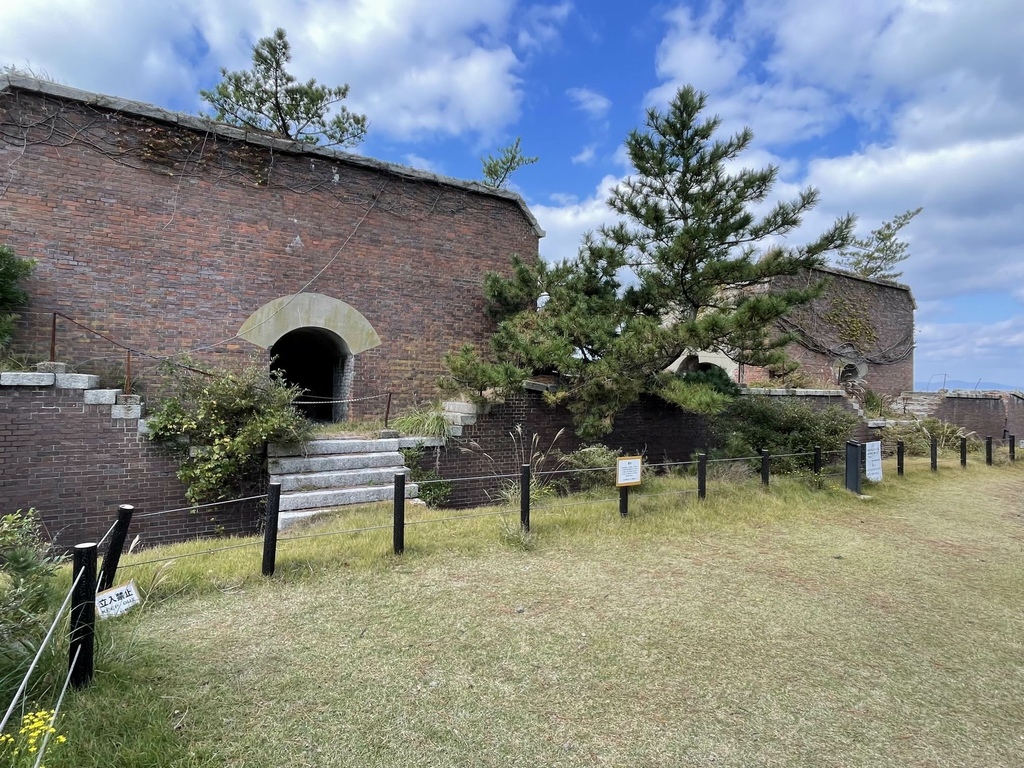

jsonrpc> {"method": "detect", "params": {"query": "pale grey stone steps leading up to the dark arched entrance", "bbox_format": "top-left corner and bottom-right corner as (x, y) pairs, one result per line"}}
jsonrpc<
(267, 437), (440, 529)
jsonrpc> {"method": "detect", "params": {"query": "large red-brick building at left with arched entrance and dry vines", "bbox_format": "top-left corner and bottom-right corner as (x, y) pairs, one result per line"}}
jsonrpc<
(0, 77), (543, 420)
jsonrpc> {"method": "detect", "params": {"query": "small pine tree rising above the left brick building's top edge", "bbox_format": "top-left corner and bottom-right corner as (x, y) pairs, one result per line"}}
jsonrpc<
(200, 29), (368, 146)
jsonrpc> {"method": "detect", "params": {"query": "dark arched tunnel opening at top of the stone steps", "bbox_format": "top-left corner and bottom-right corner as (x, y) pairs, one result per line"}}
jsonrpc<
(270, 328), (349, 422)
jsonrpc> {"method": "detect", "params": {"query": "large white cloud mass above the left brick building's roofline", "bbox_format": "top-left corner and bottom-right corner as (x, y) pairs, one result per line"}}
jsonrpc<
(0, 0), (544, 139)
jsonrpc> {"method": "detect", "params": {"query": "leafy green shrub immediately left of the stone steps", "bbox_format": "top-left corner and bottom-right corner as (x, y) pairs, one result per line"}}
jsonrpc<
(148, 364), (312, 503)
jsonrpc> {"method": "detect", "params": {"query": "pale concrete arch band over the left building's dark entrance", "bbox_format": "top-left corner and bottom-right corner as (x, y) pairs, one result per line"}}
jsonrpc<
(239, 293), (381, 354)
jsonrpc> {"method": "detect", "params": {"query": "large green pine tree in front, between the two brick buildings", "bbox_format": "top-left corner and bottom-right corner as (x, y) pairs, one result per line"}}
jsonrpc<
(447, 87), (854, 437)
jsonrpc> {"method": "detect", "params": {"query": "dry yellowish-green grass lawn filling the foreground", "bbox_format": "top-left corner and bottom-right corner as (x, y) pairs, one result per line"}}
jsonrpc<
(28, 463), (1024, 768)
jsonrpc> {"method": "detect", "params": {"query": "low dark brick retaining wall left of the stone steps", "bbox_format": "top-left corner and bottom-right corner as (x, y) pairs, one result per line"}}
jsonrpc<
(0, 386), (259, 548)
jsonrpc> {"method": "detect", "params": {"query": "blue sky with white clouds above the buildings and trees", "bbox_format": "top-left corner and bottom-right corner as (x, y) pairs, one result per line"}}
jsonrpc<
(0, 0), (1024, 388)
